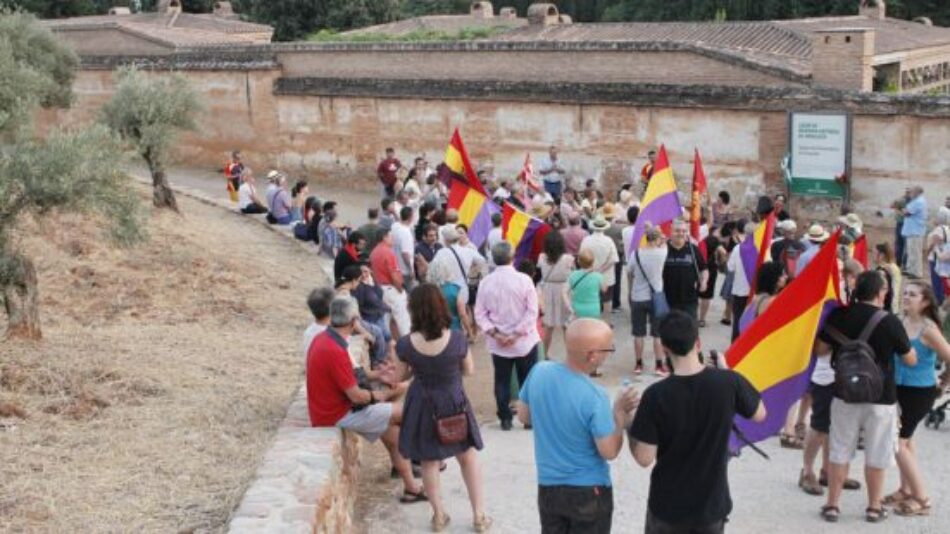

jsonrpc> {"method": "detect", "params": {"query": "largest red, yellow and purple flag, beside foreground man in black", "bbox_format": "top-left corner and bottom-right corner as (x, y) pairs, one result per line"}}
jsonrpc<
(726, 233), (842, 453)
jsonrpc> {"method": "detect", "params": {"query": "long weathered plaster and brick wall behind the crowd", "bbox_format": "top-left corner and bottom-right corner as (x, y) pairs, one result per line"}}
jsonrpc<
(33, 52), (950, 237)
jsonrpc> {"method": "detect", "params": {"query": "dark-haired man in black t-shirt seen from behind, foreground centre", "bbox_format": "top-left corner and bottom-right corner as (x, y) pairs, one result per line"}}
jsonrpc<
(629, 310), (765, 534)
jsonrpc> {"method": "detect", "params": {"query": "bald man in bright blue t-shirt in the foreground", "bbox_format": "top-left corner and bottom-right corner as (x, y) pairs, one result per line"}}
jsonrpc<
(518, 319), (639, 534)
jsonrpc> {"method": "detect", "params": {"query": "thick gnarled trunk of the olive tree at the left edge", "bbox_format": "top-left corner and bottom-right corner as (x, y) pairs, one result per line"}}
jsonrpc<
(3, 255), (43, 340)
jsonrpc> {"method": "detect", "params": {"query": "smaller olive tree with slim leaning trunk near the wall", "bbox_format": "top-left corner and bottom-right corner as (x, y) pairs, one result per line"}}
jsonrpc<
(101, 67), (202, 211)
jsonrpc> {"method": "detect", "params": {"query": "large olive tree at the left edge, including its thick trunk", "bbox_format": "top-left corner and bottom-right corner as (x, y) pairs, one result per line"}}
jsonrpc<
(0, 12), (142, 339)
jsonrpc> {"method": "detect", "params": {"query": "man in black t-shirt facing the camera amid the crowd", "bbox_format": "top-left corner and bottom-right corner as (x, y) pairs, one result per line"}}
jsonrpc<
(663, 219), (709, 319)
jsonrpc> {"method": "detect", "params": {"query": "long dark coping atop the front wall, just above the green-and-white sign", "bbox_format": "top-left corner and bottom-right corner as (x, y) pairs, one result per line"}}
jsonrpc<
(274, 77), (950, 118)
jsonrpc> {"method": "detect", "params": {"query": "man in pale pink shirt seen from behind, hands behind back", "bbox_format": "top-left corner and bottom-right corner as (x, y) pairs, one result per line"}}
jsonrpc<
(475, 241), (541, 430)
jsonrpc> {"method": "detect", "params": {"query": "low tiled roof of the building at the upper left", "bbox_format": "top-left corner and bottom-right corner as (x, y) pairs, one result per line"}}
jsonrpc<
(43, 13), (274, 48)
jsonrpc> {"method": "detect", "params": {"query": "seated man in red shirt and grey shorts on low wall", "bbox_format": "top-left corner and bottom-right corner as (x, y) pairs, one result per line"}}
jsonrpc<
(307, 297), (426, 502)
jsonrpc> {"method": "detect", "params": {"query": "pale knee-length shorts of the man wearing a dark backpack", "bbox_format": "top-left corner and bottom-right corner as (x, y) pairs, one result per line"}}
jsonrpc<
(828, 398), (897, 469)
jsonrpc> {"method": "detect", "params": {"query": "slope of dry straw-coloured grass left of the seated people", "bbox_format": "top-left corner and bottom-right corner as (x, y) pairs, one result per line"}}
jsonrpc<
(0, 191), (322, 532)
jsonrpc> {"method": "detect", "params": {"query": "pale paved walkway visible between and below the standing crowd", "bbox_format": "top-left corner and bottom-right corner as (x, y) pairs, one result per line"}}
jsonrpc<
(154, 169), (950, 534)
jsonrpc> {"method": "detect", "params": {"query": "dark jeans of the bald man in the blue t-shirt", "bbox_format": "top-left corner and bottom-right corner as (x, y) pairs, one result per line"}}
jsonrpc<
(538, 486), (614, 534)
